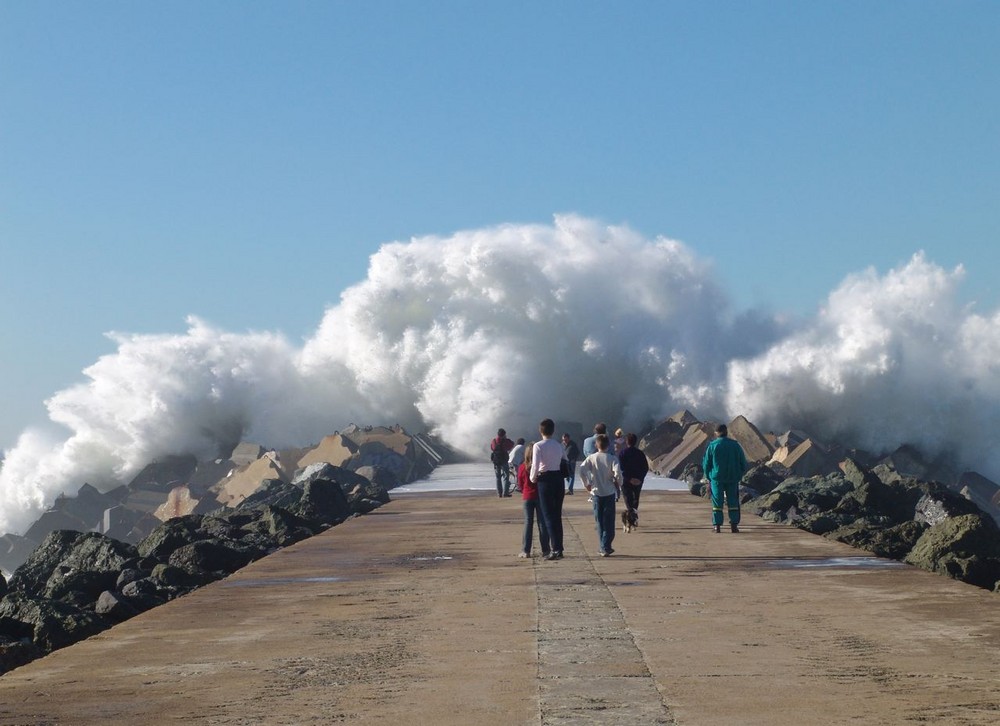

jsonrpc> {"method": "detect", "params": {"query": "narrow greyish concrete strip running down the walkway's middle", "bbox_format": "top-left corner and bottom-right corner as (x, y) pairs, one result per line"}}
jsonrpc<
(534, 520), (674, 726)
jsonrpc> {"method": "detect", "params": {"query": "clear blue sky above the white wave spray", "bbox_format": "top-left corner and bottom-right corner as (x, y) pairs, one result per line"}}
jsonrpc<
(0, 0), (1000, 447)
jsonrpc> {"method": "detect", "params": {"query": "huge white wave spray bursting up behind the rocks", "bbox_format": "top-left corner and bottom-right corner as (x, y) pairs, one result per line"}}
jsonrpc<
(0, 215), (1000, 532)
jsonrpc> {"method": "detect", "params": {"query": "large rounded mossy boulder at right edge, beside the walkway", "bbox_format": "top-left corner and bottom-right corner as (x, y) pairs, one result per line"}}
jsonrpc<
(906, 513), (1000, 590)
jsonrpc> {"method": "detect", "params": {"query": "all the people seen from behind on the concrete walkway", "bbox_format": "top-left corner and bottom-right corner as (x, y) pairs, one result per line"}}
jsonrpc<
(490, 418), (747, 560)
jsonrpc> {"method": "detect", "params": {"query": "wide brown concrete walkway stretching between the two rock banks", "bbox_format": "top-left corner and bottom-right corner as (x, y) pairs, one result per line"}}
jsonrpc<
(0, 474), (1000, 726)
